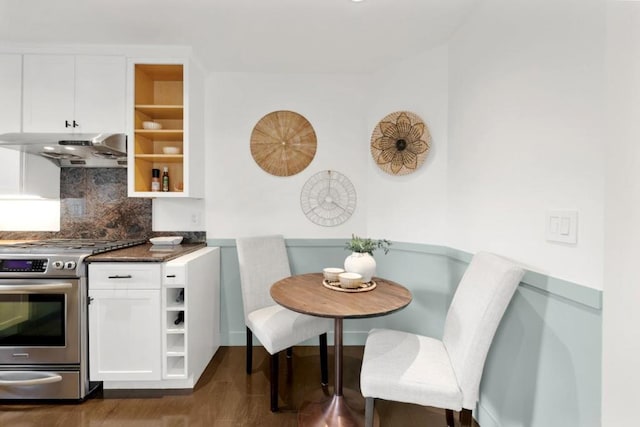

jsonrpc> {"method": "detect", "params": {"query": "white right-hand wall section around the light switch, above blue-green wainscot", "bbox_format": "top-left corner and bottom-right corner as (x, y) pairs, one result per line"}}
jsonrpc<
(447, 0), (608, 289)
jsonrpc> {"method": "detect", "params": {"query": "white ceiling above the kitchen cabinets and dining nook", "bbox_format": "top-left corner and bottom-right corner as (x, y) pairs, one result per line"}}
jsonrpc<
(0, 0), (479, 73)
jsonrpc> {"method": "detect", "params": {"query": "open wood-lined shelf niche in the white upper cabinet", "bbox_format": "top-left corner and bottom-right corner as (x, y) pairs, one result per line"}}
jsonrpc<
(133, 64), (186, 196)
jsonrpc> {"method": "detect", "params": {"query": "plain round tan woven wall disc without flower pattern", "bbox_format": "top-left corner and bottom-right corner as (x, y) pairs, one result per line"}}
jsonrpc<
(251, 111), (317, 176)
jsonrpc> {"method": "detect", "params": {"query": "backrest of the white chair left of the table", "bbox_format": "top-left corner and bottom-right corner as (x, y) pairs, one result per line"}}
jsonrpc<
(236, 235), (291, 322)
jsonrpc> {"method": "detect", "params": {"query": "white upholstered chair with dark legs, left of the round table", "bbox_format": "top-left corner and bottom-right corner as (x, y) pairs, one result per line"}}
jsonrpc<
(236, 235), (333, 412)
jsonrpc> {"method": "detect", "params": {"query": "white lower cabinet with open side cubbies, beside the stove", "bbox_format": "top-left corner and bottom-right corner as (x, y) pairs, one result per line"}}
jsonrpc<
(89, 248), (220, 389)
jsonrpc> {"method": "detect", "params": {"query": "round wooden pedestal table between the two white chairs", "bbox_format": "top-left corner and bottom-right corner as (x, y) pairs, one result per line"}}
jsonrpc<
(271, 273), (412, 427)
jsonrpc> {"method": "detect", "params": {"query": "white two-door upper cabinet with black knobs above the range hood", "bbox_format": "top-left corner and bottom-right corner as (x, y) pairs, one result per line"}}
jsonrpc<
(23, 54), (126, 133)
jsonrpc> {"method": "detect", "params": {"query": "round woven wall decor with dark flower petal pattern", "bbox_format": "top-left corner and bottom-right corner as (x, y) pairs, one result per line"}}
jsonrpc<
(371, 111), (431, 175)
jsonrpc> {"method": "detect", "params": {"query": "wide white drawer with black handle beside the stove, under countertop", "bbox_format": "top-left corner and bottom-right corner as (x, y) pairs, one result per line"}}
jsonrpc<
(89, 263), (161, 289)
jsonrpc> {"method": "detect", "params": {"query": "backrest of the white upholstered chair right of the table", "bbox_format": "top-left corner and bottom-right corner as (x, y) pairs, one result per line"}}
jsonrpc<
(442, 252), (524, 409)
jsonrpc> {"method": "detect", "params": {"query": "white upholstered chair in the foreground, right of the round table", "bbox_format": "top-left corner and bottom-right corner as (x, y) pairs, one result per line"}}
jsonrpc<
(360, 252), (524, 427)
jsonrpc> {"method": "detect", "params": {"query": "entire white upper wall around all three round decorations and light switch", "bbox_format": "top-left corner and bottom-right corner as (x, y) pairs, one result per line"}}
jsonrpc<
(205, 0), (606, 289)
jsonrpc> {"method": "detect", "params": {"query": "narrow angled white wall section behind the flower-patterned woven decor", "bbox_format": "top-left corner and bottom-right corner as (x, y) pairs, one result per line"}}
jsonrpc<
(362, 46), (448, 244)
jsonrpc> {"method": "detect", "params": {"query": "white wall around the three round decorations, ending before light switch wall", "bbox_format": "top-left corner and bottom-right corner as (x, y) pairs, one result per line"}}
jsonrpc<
(206, 47), (447, 243)
